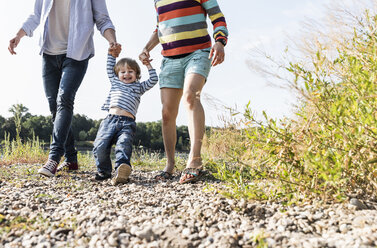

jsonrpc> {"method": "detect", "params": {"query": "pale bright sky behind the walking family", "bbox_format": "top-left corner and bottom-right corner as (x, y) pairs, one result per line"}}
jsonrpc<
(0, 0), (330, 126)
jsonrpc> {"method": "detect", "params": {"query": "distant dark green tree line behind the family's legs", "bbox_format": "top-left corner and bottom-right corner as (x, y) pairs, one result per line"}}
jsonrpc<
(0, 104), (194, 151)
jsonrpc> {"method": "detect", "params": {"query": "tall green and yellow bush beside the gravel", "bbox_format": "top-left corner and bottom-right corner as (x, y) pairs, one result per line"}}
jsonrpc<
(204, 11), (377, 202)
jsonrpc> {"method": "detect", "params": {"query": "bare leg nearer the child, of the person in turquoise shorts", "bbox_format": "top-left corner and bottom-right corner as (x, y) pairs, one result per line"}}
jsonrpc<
(161, 88), (182, 173)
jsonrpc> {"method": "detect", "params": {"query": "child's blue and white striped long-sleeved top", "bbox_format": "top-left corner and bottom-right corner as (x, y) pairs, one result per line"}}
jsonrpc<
(101, 54), (158, 117)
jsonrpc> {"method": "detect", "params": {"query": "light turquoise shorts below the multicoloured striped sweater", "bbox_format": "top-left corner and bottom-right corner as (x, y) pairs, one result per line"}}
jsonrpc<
(159, 48), (211, 89)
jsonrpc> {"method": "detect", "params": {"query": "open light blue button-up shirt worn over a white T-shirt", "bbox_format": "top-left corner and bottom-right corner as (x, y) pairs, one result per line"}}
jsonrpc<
(22, 0), (115, 61)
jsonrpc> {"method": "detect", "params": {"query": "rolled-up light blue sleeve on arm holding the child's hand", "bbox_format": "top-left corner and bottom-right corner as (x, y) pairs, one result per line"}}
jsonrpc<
(92, 0), (115, 35)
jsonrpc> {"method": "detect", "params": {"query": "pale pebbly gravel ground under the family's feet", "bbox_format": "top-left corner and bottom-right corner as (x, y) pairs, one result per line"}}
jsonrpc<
(0, 165), (377, 247)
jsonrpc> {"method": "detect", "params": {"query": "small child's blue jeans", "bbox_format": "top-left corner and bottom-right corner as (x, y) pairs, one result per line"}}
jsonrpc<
(93, 115), (136, 175)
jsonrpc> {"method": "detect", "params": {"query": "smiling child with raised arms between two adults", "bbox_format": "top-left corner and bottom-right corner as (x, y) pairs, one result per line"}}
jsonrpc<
(93, 44), (158, 185)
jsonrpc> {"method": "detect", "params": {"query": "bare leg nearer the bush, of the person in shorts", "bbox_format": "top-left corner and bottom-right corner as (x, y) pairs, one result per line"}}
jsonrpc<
(183, 73), (205, 168)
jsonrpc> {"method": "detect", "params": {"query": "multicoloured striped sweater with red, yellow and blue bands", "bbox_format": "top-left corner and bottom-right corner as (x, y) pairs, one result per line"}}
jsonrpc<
(154, 0), (228, 56)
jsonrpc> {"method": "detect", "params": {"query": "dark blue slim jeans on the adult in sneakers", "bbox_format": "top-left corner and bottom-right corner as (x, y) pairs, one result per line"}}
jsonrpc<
(42, 54), (89, 163)
